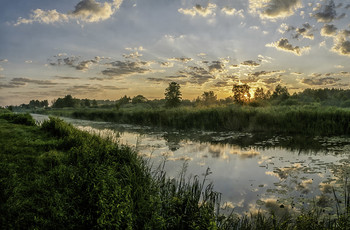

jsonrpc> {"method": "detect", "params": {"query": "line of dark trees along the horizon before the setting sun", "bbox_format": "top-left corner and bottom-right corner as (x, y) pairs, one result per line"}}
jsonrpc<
(7, 82), (350, 109)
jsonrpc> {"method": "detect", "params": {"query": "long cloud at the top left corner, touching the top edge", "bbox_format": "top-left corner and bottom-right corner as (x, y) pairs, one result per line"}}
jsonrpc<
(14, 0), (123, 26)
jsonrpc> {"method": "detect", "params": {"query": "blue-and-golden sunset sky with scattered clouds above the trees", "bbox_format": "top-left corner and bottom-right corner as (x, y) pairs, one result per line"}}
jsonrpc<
(0, 0), (350, 106)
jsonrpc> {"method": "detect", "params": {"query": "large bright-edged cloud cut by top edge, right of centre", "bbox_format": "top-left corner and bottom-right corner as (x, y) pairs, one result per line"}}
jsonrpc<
(249, 0), (302, 19)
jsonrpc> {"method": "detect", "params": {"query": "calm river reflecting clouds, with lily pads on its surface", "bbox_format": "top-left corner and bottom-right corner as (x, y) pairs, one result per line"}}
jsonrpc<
(32, 114), (350, 217)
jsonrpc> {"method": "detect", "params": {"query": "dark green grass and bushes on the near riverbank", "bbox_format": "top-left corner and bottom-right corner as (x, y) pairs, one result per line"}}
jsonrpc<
(0, 111), (350, 229)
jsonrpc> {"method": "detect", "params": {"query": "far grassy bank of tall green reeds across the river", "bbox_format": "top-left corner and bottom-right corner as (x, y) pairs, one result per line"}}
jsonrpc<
(37, 106), (350, 135)
